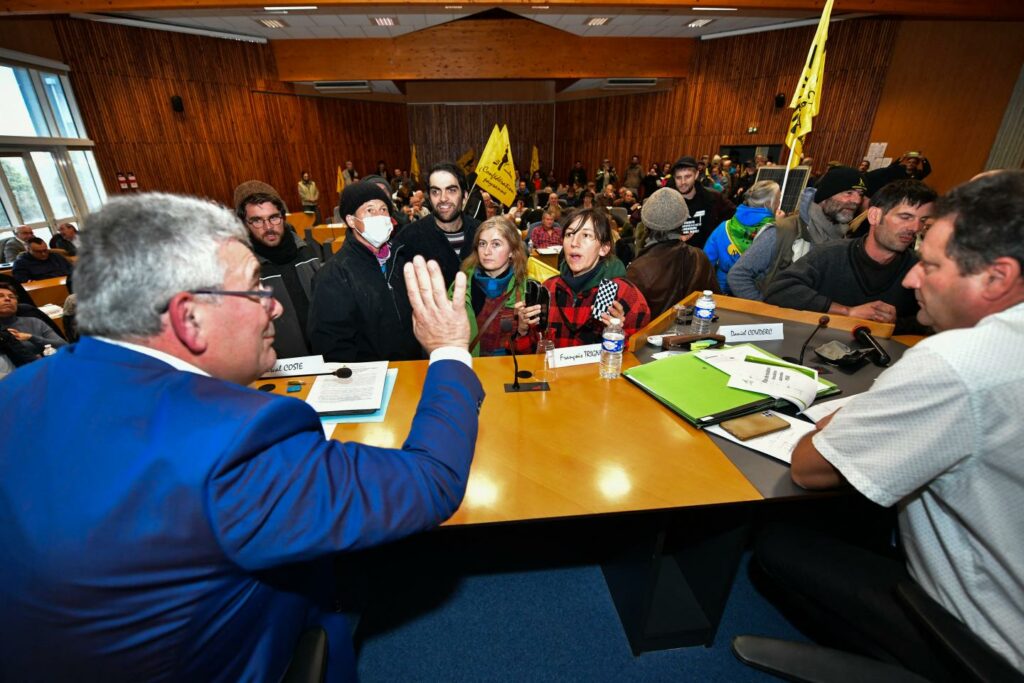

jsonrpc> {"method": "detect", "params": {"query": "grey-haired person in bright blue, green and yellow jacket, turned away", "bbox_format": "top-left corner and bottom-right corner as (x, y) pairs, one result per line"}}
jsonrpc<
(705, 180), (782, 294)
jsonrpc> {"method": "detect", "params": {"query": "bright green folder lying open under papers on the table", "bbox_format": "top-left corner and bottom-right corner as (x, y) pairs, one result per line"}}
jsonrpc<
(623, 344), (839, 427)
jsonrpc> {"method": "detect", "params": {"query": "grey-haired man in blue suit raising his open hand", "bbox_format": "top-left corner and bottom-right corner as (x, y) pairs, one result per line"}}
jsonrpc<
(0, 195), (483, 681)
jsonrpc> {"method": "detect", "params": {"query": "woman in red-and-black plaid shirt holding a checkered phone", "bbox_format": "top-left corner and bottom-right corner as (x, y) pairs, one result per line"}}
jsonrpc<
(516, 209), (650, 352)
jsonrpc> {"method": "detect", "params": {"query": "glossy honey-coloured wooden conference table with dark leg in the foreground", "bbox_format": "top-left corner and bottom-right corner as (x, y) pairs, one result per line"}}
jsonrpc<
(261, 295), (902, 653)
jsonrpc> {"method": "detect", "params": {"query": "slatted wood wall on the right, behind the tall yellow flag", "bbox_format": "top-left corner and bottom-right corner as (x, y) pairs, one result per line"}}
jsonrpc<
(555, 19), (898, 181)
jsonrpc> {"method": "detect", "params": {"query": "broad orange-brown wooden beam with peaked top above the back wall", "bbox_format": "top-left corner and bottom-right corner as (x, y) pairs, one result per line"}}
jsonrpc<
(270, 19), (695, 81)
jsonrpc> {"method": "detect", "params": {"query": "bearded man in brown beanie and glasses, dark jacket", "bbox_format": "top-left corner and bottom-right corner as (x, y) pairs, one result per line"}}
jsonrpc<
(234, 180), (321, 358)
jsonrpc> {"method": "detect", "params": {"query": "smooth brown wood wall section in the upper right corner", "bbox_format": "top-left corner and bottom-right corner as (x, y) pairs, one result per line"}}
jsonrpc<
(868, 22), (1024, 191)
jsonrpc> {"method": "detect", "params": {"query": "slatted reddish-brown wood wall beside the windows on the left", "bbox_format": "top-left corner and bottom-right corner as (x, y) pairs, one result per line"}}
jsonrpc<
(55, 18), (410, 217)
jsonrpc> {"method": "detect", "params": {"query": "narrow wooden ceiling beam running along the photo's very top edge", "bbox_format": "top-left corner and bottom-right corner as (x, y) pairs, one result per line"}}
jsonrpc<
(0, 0), (1024, 20)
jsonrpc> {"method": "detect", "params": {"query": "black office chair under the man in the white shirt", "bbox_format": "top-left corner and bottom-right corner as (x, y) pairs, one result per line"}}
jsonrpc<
(732, 581), (1024, 683)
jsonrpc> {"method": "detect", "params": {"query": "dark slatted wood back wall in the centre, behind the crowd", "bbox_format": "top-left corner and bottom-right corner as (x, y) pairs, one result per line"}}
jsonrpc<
(409, 102), (555, 181)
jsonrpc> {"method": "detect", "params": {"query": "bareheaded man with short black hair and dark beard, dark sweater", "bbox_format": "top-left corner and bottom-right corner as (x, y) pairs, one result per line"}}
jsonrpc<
(395, 162), (483, 285)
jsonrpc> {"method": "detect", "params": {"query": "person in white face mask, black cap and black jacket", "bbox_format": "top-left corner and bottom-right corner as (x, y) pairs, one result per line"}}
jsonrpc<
(308, 182), (426, 361)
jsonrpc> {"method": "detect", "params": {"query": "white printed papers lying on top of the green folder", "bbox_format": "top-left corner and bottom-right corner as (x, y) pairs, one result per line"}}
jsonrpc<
(696, 345), (828, 412)
